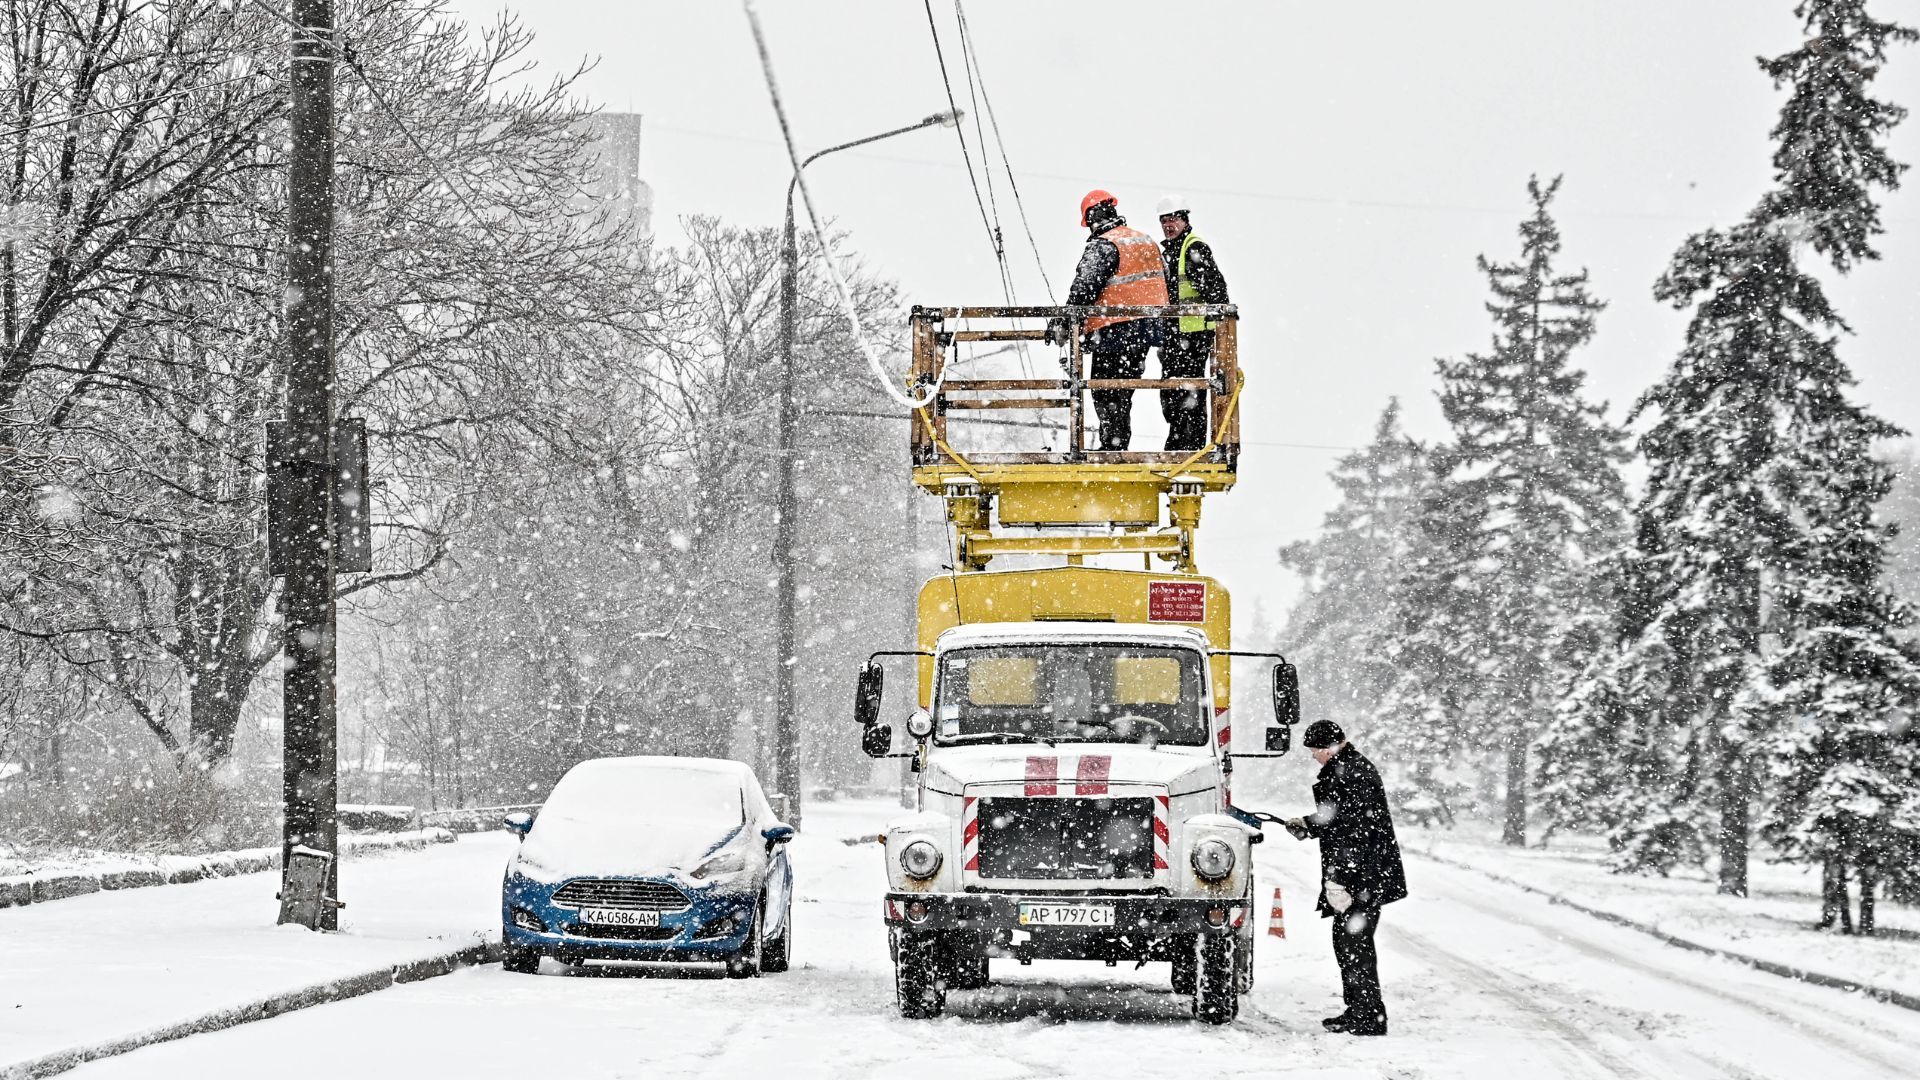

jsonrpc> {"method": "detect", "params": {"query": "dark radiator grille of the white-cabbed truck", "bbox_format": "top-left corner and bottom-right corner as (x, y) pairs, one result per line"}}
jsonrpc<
(979, 798), (1154, 880)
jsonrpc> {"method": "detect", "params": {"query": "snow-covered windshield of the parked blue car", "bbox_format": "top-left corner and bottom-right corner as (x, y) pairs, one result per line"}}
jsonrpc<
(540, 767), (747, 828)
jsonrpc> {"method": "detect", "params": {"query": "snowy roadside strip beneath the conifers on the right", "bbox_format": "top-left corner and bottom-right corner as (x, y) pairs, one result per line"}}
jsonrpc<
(1400, 826), (1920, 1007)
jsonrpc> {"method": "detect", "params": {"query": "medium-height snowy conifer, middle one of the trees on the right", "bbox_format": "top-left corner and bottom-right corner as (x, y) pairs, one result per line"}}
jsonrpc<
(1388, 177), (1624, 846)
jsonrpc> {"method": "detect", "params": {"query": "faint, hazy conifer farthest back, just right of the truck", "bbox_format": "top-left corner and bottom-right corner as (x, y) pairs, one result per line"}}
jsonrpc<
(1279, 400), (1423, 726)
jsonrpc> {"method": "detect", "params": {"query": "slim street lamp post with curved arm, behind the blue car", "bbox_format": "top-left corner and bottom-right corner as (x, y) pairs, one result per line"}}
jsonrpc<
(774, 110), (966, 826)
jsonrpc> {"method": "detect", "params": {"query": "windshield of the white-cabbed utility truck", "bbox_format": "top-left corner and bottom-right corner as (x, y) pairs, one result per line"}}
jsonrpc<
(933, 642), (1210, 746)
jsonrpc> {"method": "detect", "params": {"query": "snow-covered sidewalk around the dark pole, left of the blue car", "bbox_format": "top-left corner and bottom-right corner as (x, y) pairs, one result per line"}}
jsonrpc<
(0, 822), (515, 1076)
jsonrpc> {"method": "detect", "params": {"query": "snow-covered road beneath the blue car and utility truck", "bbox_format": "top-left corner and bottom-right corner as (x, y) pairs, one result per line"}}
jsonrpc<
(60, 803), (1920, 1080)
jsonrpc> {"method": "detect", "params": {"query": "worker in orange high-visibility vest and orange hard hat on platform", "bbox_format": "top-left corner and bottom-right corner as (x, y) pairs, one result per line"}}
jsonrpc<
(1048, 188), (1167, 450)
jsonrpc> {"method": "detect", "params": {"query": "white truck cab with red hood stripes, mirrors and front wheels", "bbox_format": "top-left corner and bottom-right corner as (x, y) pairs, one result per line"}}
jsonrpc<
(856, 621), (1298, 1022)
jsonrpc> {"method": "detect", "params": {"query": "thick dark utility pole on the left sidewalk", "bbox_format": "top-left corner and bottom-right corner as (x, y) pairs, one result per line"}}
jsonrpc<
(280, 0), (340, 930)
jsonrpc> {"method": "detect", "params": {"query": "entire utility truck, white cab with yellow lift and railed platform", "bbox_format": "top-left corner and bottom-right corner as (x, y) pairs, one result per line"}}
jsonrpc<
(854, 306), (1300, 1024)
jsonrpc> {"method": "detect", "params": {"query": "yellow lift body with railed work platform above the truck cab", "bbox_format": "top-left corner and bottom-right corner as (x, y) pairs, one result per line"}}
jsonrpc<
(910, 304), (1244, 707)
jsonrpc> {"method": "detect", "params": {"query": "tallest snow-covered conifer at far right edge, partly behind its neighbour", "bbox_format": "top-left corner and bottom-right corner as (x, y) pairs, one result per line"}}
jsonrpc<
(1741, 0), (1920, 922)
